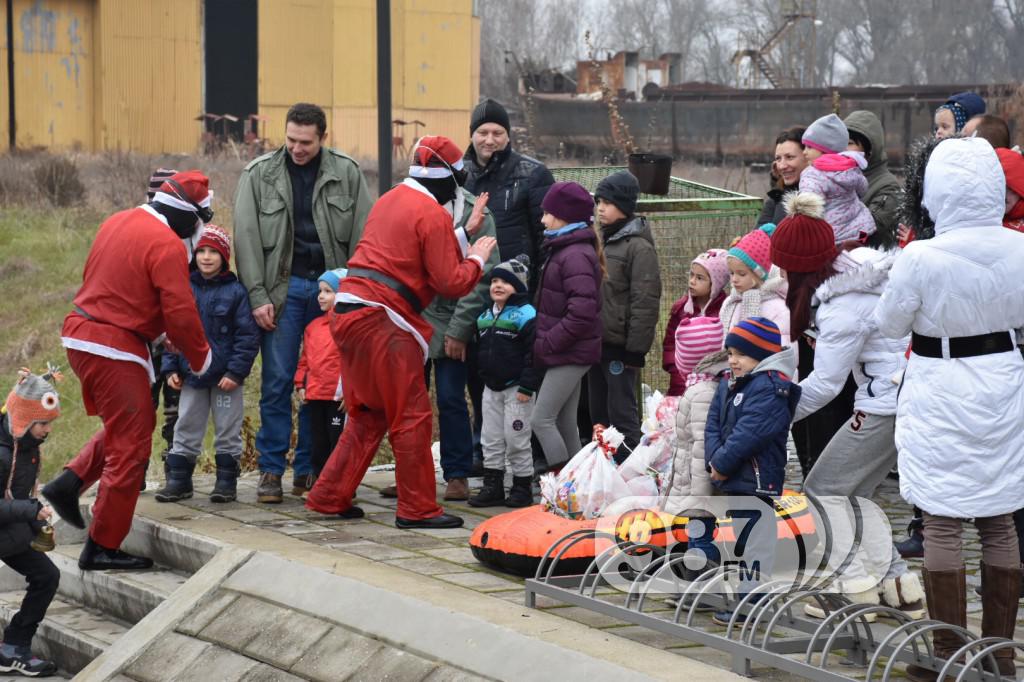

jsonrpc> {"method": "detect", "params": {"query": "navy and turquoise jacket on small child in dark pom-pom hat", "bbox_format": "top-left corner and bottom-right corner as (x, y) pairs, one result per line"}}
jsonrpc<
(476, 294), (544, 395)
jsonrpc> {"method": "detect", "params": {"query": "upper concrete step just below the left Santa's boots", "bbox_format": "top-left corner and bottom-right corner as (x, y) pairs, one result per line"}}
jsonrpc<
(46, 545), (188, 624)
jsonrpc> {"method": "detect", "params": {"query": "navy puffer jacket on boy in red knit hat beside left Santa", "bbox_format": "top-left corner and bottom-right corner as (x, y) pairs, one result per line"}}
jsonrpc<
(161, 270), (260, 388)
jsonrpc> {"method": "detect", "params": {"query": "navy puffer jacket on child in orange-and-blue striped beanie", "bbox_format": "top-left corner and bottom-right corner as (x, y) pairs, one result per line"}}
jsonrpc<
(705, 347), (800, 496)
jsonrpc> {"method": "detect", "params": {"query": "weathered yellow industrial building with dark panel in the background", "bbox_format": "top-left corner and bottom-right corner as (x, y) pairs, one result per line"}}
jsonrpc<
(0, 0), (480, 158)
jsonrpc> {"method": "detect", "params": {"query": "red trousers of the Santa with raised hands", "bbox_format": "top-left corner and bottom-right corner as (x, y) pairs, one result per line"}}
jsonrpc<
(306, 307), (442, 520)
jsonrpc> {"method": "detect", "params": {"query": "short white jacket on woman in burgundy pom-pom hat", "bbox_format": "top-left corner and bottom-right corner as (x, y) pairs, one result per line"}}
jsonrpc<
(795, 248), (910, 420)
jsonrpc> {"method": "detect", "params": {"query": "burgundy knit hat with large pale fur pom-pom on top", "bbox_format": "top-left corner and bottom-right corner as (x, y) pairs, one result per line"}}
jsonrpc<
(771, 191), (839, 272)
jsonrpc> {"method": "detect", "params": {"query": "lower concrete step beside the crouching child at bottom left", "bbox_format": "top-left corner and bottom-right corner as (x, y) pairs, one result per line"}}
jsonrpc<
(0, 590), (131, 674)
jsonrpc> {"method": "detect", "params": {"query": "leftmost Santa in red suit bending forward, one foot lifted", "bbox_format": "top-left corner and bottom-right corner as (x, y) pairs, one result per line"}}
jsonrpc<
(42, 171), (213, 570)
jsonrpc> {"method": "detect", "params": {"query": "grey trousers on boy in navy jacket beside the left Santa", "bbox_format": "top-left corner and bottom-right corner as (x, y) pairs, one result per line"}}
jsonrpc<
(171, 385), (245, 462)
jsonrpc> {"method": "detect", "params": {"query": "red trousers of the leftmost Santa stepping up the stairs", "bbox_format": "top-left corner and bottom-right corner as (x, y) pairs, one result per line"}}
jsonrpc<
(68, 349), (157, 549)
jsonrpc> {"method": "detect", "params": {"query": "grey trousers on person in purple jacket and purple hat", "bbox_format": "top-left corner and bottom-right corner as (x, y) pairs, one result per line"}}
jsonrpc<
(532, 365), (590, 466)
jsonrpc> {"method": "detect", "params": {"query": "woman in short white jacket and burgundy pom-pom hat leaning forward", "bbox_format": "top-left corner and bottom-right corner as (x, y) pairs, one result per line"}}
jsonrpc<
(771, 191), (925, 619)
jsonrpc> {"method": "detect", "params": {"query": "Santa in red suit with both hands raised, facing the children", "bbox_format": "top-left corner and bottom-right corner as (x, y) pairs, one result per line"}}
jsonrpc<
(306, 137), (497, 528)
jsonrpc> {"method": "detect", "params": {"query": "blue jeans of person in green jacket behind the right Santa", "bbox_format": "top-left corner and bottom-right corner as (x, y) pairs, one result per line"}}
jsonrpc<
(426, 357), (473, 480)
